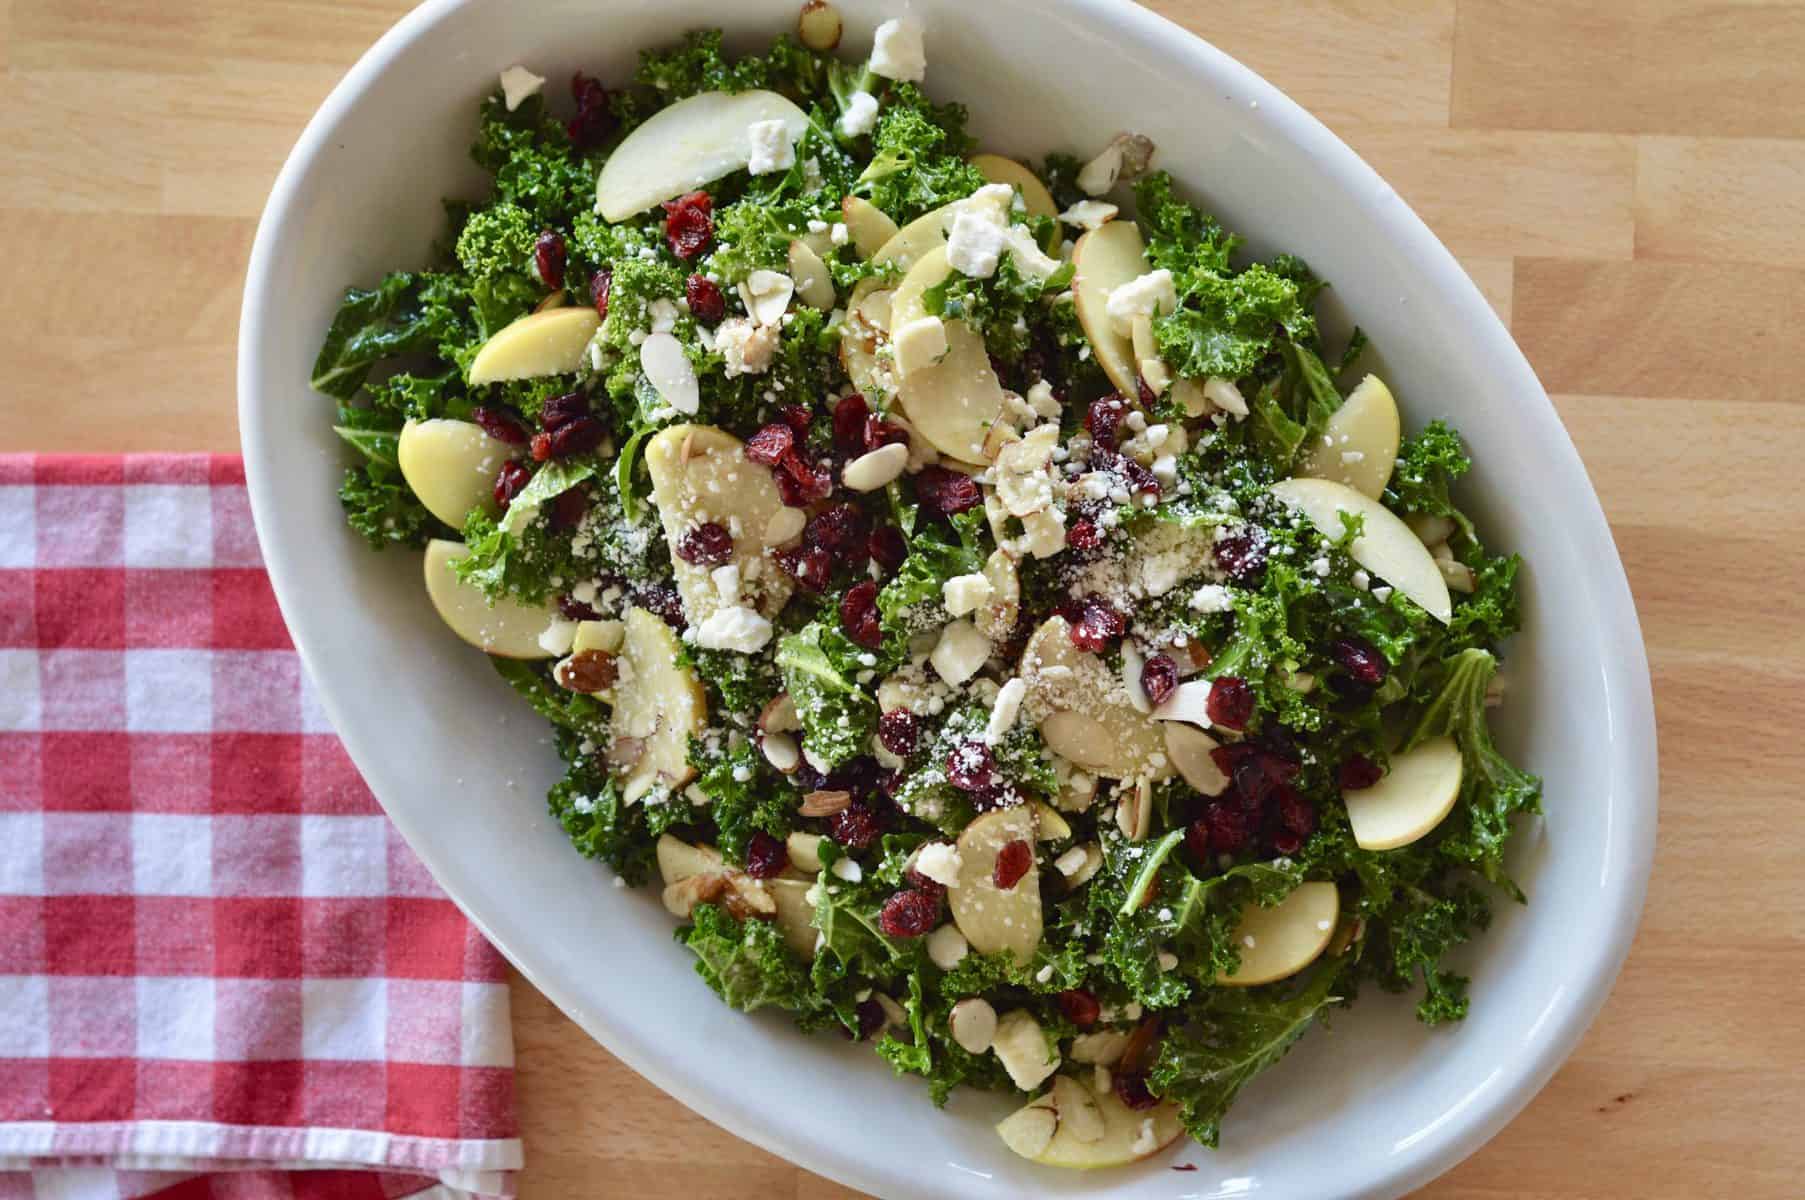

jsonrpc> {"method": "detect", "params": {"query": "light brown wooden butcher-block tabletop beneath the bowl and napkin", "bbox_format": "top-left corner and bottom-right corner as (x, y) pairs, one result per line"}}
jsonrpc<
(0, 0), (1805, 1200)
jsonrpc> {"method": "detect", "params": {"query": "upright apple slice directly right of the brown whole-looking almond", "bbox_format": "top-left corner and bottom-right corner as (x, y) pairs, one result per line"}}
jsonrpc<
(608, 608), (708, 805)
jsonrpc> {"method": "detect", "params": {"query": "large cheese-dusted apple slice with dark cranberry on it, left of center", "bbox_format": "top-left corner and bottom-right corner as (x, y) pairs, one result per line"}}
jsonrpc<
(644, 426), (792, 624)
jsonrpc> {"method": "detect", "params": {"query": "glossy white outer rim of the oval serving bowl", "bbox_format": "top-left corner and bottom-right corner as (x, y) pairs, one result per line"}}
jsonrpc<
(238, 0), (1659, 1196)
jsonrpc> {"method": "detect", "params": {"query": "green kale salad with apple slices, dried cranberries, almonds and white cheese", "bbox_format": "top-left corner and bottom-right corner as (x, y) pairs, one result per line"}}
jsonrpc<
(312, 0), (1540, 1168)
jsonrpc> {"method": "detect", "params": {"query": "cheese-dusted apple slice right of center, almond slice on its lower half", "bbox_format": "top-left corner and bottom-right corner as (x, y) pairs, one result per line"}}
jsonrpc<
(1022, 617), (1173, 780)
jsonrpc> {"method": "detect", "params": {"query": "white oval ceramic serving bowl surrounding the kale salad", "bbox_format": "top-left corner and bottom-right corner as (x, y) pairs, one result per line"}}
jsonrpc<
(238, 0), (1657, 1198)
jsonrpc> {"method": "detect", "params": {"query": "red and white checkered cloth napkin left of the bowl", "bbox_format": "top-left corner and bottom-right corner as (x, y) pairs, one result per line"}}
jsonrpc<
(0, 455), (520, 1200)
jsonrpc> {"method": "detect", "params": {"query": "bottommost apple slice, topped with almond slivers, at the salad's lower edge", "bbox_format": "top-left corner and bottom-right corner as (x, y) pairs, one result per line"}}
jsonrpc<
(996, 1075), (1184, 1171)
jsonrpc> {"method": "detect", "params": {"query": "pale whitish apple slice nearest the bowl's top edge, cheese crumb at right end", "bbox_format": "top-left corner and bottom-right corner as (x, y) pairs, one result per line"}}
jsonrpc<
(596, 92), (809, 222)
